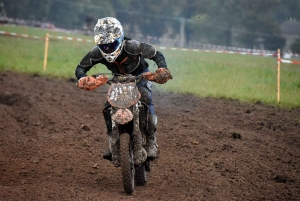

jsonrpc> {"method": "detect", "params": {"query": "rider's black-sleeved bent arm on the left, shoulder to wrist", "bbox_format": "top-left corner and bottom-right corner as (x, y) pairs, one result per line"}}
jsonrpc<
(75, 47), (103, 80)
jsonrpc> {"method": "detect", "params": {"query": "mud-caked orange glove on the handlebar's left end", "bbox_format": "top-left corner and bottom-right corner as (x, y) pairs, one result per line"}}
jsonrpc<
(77, 75), (108, 91)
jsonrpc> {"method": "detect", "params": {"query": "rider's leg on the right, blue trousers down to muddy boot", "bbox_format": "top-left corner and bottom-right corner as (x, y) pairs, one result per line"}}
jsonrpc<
(138, 80), (158, 158)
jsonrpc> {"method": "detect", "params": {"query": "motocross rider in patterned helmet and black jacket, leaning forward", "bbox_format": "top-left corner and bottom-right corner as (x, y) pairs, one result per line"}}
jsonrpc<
(75, 17), (172, 166)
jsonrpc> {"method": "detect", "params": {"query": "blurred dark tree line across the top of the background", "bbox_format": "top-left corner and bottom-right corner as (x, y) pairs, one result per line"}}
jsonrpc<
(0, 0), (300, 50)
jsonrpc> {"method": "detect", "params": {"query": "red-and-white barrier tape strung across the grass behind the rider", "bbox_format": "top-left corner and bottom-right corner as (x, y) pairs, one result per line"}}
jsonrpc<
(0, 30), (300, 64)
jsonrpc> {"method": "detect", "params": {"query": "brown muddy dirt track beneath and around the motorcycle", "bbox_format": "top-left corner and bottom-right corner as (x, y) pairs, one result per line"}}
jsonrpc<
(0, 72), (300, 201)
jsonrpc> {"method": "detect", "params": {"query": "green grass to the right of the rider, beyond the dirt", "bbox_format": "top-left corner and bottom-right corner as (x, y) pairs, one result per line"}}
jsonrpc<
(165, 52), (300, 107)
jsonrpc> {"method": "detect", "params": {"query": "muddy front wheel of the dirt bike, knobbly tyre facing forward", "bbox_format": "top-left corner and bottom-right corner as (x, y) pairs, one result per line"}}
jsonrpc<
(120, 133), (135, 194)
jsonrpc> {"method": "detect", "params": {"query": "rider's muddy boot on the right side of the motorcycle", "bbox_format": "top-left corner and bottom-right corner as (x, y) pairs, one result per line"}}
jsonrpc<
(145, 115), (159, 158)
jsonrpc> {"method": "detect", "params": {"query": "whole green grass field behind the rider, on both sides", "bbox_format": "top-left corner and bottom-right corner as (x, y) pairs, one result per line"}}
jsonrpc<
(0, 26), (300, 107)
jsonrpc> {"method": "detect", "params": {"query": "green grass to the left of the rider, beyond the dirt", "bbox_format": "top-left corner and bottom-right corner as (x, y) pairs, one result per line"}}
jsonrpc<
(0, 23), (108, 78)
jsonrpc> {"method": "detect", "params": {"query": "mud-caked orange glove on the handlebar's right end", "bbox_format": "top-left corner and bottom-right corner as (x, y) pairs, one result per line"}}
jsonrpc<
(142, 68), (173, 84)
